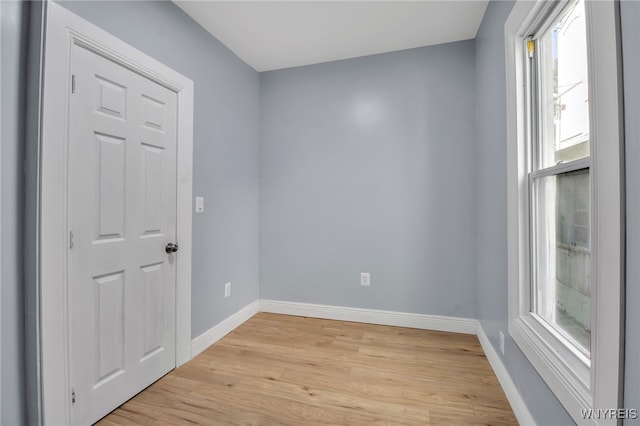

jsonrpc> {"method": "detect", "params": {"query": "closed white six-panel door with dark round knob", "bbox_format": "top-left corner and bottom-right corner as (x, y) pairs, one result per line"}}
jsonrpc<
(67, 45), (178, 424)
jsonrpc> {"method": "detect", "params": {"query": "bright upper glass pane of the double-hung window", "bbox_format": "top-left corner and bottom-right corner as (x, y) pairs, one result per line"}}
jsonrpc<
(538, 1), (589, 168)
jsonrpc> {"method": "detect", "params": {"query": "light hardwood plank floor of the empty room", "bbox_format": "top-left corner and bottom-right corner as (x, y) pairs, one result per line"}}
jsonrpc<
(98, 313), (517, 426)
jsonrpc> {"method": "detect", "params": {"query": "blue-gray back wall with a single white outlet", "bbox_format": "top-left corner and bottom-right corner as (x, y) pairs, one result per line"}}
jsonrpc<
(260, 41), (476, 317)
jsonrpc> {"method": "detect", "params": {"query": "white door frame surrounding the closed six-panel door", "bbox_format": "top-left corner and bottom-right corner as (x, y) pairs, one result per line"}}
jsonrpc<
(36, 1), (194, 424)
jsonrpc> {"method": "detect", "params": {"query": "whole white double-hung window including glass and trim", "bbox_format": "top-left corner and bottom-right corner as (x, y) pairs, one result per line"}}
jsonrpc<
(505, 0), (624, 424)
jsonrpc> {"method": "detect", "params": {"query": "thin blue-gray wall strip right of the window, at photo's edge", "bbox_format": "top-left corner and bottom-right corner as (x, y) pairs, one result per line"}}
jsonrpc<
(620, 1), (640, 425)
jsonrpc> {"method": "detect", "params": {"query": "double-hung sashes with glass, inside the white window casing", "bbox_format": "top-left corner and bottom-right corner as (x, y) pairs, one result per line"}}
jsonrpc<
(528, 0), (591, 357)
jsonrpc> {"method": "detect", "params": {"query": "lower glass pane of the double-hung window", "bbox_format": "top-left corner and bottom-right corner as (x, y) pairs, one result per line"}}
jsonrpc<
(534, 169), (591, 353)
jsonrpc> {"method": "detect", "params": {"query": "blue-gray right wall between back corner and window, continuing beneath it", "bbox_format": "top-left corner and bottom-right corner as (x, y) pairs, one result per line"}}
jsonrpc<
(475, 1), (573, 425)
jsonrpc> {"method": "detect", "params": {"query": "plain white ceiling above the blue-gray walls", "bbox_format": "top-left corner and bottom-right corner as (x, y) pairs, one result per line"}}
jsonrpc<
(174, 0), (488, 71)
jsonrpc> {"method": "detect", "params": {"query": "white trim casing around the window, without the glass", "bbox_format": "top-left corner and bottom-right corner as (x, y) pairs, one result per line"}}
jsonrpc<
(505, 0), (624, 424)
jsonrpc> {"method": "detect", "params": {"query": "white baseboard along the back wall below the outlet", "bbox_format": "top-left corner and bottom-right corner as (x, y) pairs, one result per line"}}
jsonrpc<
(260, 300), (478, 334)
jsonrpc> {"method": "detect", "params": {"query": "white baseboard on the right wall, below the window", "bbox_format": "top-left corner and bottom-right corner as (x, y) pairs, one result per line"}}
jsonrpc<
(477, 322), (536, 426)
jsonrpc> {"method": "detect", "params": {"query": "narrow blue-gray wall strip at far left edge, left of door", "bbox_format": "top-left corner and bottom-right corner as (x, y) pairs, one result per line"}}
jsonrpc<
(0, 1), (29, 425)
